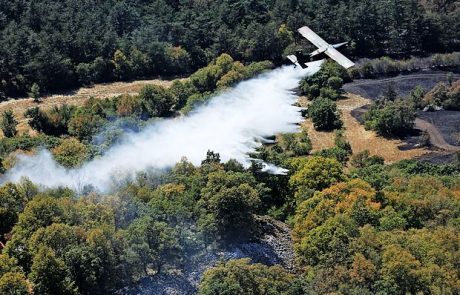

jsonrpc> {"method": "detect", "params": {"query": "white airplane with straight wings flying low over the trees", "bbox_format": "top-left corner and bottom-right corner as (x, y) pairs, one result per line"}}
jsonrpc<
(287, 26), (355, 69)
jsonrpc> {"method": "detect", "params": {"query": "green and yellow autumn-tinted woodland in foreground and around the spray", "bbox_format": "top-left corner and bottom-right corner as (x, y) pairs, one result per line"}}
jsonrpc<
(0, 54), (460, 295)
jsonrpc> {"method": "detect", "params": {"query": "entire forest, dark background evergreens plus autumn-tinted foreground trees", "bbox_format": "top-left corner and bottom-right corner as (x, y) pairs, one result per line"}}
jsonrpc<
(0, 0), (460, 295)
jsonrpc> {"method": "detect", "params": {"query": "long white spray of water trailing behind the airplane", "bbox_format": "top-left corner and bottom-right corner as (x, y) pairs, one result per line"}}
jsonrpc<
(2, 62), (321, 191)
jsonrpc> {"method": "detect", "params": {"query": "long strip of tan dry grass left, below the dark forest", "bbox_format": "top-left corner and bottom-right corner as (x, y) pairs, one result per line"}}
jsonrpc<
(0, 79), (176, 136)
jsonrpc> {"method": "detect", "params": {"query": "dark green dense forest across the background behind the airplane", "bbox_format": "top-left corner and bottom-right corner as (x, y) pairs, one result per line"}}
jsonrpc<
(0, 0), (460, 100)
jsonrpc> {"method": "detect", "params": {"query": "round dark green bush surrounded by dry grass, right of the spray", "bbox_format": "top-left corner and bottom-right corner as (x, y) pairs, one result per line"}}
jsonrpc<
(308, 97), (342, 131)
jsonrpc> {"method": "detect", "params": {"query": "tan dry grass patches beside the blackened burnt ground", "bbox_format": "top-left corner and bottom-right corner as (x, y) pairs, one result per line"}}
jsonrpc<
(303, 94), (429, 163)
